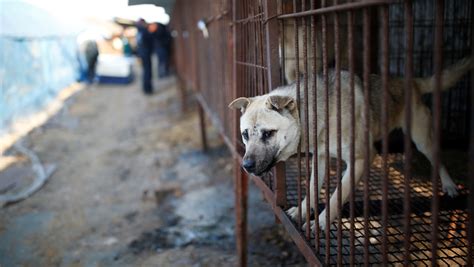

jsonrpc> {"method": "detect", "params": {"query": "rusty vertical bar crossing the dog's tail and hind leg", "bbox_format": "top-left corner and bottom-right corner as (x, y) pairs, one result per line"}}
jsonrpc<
(431, 0), (444, 266)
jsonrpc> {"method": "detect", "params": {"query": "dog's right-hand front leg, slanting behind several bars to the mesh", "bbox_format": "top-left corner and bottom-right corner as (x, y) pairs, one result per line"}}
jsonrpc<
(311, 158), (364, 231)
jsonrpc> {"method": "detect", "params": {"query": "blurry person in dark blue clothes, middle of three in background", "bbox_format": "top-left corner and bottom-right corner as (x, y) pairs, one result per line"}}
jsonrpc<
(136, 19), (154, 94)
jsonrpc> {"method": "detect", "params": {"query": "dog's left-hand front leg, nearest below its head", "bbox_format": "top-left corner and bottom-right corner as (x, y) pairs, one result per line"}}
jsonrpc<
(287, 154), (326, 224)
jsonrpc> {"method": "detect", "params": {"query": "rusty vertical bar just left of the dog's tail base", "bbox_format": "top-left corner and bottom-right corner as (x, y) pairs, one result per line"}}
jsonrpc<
(403, 0), (413, 265)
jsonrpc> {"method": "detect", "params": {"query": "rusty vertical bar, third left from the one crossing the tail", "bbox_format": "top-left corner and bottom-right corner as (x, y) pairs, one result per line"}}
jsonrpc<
(363, 8), (372, 266)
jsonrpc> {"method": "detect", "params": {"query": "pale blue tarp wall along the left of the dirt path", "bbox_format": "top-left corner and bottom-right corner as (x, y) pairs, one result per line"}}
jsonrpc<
(0, 1), (79, 135)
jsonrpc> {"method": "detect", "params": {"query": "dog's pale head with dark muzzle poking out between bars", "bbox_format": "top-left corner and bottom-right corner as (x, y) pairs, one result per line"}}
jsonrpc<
(229, 95), (300, 175)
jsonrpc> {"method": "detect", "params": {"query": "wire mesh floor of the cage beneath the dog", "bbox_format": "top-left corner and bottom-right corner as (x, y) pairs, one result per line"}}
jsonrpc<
(264, 154), (468, 266)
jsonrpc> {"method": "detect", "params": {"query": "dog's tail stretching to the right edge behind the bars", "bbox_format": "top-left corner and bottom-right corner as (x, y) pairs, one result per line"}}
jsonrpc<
(414, 56), (474, 94)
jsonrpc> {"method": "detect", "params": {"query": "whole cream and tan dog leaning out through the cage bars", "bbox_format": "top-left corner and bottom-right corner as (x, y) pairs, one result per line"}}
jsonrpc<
(229, 58), (474, 229)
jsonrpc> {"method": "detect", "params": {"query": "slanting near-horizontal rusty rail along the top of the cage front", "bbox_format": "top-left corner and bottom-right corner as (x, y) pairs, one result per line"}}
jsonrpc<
(278, 0), (398, 19)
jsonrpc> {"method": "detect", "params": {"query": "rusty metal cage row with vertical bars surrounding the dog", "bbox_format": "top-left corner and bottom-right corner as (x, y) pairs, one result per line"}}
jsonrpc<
(171, 0), (474, 266)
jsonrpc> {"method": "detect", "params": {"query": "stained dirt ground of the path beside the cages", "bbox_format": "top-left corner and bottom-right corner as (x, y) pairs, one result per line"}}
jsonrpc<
(0, 74), (306, 267)
